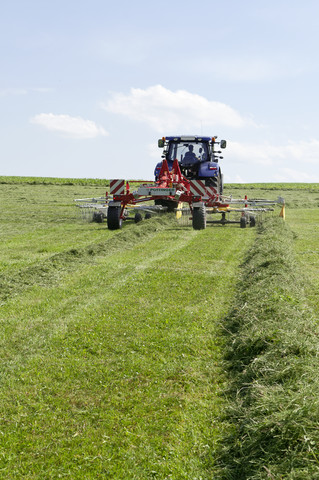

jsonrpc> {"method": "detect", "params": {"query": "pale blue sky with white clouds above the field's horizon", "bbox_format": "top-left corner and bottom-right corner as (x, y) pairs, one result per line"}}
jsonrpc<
(0, 0), (319, 183)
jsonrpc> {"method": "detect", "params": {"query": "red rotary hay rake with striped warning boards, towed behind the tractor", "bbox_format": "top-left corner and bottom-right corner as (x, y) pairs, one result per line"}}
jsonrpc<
(106, 159), (284, 230)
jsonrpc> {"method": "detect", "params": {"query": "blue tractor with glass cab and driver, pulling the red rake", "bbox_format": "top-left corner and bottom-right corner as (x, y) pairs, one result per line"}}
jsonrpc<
(154, 135), (226, 195)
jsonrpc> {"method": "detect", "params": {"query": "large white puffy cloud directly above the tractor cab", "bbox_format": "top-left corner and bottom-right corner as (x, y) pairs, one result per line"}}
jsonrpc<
(102, 85), (253, 135)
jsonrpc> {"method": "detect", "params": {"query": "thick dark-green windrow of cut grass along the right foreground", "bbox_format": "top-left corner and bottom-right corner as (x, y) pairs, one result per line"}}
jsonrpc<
(218, 219), (319, 480)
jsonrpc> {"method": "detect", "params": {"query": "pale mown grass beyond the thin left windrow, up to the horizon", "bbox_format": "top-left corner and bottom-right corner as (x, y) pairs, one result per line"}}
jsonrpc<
(0, 183), (115, 274)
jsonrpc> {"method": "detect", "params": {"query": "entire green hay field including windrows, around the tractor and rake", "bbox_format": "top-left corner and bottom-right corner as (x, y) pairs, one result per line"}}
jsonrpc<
(0, 177), (319, 480)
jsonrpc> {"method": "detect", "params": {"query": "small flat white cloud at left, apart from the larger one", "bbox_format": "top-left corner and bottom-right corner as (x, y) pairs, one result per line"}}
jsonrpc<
(30, 113), (109, 138)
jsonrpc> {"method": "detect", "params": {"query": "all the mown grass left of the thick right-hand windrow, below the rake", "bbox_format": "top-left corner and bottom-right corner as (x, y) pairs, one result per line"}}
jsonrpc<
(0, 181), (255, 480)
